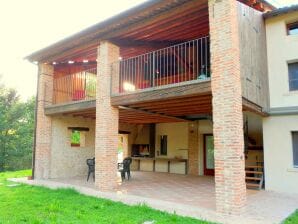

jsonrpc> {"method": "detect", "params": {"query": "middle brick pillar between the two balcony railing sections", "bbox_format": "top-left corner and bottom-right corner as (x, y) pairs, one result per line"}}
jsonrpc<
(95, 41), (119, 191)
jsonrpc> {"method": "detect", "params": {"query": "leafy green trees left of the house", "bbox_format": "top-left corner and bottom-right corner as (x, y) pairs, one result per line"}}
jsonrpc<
(0, 80), (35, 172)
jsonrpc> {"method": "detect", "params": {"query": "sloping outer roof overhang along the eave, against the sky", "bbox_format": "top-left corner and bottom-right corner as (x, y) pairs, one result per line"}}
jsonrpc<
(25, 0), (274, 62)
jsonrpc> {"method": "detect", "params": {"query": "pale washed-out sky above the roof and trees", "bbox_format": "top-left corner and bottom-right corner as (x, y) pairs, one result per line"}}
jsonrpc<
(0, 0), (298, 99)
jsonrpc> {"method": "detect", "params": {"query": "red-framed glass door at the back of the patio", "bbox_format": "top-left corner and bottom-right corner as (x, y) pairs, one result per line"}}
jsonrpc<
(204, 134), (214, 176)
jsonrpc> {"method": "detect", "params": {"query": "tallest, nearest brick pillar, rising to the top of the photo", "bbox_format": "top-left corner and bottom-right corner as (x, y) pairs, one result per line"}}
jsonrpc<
(209, 0), (246, 214)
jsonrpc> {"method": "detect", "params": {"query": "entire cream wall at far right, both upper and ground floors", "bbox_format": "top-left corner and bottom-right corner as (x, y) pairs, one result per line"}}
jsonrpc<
(263, 12), (298, 193)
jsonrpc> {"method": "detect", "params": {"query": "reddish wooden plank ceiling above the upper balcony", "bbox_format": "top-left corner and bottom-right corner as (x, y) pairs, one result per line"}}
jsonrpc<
(49, 0), (209, 62)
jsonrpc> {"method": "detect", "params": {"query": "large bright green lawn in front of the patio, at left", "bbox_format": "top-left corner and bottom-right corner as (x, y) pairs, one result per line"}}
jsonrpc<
(0, 170), (208, 224)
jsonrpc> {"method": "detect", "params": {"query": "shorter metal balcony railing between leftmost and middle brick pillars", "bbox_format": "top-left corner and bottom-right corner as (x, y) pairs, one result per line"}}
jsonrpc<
(53, 68), (97, 104)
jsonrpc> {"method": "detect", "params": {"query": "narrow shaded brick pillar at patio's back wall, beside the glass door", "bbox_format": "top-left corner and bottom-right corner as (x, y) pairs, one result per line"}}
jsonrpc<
(188, 121), (199, 175)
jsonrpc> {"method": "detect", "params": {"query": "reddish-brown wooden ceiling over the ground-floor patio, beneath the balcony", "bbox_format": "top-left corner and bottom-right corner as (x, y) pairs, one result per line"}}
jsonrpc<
(63, 94), (212, 124)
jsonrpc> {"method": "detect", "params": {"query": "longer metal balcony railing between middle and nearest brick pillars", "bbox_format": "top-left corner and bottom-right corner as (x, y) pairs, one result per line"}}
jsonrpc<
(111, 36), (210, 95)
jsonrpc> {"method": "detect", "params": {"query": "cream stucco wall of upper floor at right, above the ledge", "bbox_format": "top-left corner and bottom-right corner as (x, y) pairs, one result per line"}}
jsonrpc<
(266, 12), (298, 108)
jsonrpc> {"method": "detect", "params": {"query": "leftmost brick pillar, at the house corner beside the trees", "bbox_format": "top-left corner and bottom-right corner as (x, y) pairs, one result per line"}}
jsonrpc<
(34, 64), (54, 179)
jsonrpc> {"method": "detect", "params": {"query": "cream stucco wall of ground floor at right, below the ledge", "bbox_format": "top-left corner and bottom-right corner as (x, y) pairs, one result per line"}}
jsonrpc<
(263, 115), (298, 193)
